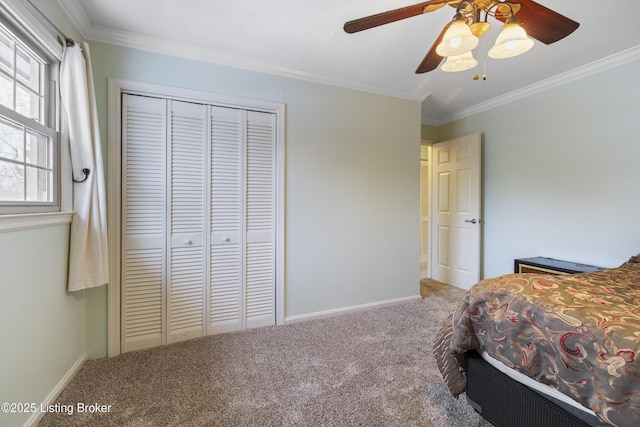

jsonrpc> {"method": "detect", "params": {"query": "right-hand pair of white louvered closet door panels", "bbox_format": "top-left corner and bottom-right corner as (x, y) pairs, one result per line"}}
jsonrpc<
(210, 107), (275, 333)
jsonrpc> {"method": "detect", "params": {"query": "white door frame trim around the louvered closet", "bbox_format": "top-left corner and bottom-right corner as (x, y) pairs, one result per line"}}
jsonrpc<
(107, 79), (285, 357)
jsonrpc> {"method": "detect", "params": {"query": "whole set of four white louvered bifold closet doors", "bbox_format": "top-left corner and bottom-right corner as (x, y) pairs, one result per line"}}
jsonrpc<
(121, 95), (276, 352)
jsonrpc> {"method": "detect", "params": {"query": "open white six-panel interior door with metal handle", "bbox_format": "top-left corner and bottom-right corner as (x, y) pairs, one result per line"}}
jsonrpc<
(431, 134), (481, 289)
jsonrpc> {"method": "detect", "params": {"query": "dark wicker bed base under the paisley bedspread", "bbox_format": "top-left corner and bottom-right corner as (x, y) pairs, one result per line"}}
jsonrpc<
(466, 351), (611, 427)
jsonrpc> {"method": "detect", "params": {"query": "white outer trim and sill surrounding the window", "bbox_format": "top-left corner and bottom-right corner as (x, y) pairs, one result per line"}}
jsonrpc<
(0, 0), (73, 232)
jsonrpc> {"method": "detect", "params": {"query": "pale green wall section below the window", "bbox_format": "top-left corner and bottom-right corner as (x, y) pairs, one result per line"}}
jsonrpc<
(0, 225), (85, 426)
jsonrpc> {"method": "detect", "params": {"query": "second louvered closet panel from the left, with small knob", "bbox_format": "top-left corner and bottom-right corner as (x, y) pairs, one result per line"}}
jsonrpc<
(167, 101), (207, 342)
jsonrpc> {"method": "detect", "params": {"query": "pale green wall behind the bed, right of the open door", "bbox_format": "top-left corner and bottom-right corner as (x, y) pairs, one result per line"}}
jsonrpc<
(439, 57), (640, 277)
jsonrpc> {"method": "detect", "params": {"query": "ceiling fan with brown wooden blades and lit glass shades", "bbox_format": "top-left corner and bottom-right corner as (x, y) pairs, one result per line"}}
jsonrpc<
(344, 0), (580, 74)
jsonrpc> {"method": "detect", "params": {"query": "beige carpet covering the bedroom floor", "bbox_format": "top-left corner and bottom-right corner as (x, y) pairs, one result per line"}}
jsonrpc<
(40, 282), (490, 427)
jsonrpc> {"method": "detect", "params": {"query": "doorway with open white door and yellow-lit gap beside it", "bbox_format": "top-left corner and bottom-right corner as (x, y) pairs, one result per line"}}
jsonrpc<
(420, 133), (482, 298)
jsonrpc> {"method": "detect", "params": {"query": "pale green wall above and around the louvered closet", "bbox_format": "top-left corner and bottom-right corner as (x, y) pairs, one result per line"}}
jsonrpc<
(87, 43), (421, 357)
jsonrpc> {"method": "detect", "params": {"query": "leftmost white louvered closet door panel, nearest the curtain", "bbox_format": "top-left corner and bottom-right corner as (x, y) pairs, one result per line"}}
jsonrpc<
(121, 95), (166, 352)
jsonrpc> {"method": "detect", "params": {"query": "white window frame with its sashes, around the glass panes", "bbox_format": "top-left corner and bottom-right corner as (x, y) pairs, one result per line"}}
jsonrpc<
(0, 0), (72, 221)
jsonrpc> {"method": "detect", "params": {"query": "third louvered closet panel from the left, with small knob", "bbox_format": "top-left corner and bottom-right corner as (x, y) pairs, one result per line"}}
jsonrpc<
(209, 107), (245, 334)
